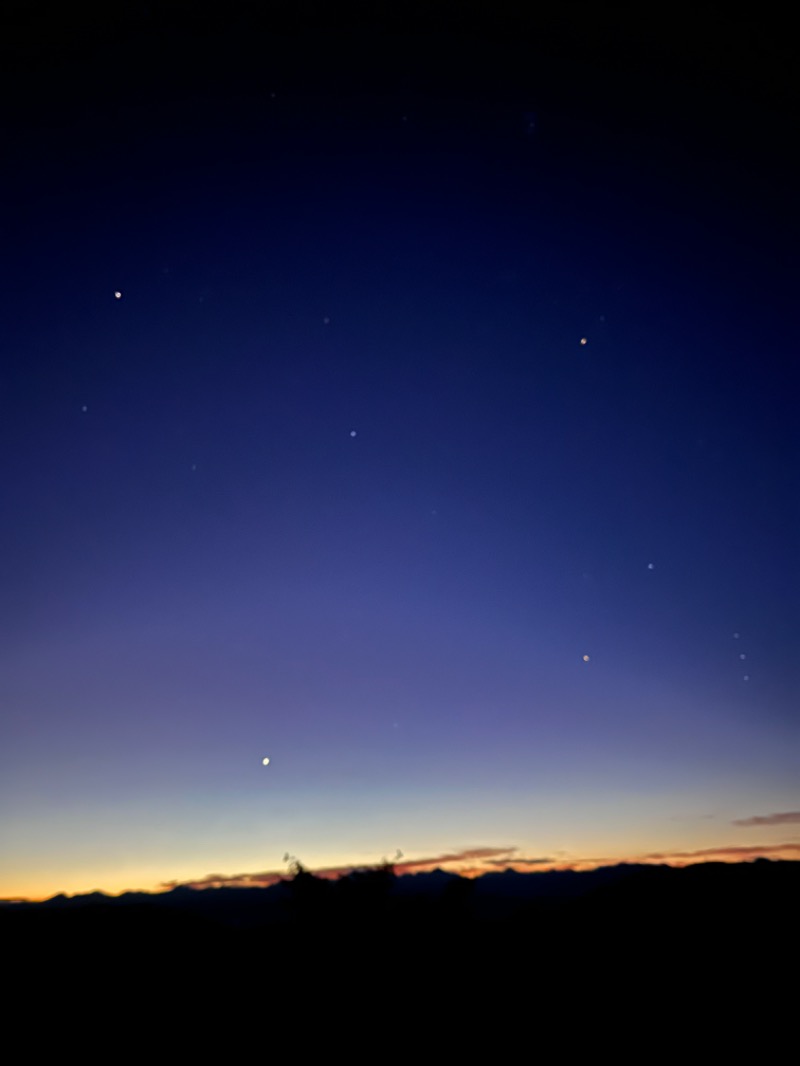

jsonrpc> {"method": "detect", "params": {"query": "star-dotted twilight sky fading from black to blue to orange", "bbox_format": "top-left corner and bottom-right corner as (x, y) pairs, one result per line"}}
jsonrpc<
(0, 4), (800, 899)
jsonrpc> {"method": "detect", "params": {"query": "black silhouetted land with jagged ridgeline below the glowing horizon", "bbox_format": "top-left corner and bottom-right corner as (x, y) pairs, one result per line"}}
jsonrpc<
(0, 859), (800, 1044)
